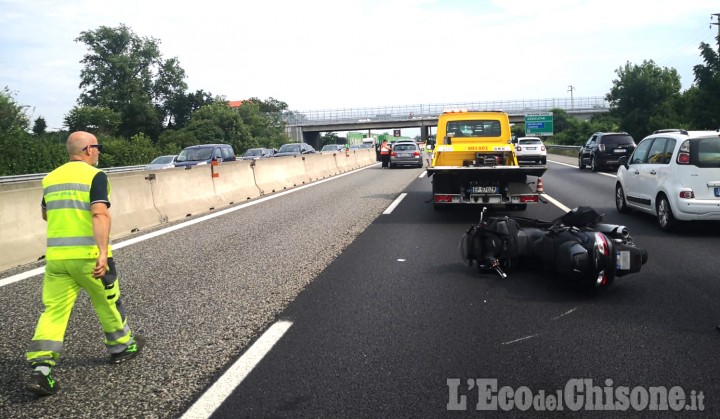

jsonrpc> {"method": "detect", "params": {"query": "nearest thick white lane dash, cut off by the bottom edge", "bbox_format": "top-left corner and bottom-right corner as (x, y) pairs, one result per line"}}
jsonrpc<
(182, 320), (292, 419)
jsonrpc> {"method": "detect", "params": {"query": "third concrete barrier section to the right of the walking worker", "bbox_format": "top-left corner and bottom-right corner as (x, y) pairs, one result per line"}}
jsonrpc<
(212, 160), (260, 204)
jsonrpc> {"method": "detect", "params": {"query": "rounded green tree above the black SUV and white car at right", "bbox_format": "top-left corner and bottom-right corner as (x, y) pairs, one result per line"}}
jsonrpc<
(606, 60), (682, 138)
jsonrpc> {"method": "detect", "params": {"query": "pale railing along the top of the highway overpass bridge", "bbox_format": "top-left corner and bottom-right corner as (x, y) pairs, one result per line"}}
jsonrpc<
(283, 96), (609, 126)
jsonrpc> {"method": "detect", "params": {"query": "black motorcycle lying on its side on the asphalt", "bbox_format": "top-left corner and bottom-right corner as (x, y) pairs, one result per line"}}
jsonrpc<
(459, 207), (648, 287)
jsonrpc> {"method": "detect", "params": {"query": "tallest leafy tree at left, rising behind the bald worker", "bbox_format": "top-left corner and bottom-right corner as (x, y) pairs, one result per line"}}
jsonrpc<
(75, 24), (187, 139)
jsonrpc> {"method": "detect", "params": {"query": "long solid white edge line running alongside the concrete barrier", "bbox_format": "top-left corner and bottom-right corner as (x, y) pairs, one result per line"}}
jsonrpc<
(0, 163), (379, 288)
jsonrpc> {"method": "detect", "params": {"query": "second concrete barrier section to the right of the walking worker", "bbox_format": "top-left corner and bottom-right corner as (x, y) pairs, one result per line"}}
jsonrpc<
(150, 164), (227, 221)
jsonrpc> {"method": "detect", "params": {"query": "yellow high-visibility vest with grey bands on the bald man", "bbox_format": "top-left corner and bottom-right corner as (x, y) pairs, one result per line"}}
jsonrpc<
(42, 162), (112, 260)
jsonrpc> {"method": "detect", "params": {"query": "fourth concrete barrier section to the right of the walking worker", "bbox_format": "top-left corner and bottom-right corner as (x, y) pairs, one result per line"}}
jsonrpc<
(253, 156), (310, 195)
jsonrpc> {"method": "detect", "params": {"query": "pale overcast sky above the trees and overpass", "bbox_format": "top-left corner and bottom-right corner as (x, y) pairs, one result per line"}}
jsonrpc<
(0, 0), (720, 130)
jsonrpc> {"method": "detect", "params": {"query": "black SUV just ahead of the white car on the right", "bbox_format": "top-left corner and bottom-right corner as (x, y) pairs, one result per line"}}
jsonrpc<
(578, 132), (635, 172)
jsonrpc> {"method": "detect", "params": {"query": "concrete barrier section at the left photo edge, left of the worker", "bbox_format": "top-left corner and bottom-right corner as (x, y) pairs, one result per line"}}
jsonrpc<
(0, 180), (47, 271)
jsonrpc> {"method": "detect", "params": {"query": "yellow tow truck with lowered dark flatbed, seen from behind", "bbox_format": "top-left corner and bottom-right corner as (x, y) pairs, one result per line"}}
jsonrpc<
(427, 110), (547, 210)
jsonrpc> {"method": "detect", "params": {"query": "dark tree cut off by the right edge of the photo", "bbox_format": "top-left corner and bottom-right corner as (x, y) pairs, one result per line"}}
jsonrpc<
(686, 33), (720, 129)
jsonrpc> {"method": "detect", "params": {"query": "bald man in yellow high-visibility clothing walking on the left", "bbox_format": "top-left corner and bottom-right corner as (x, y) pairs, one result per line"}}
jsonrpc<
(25, 131), (145, 396)
